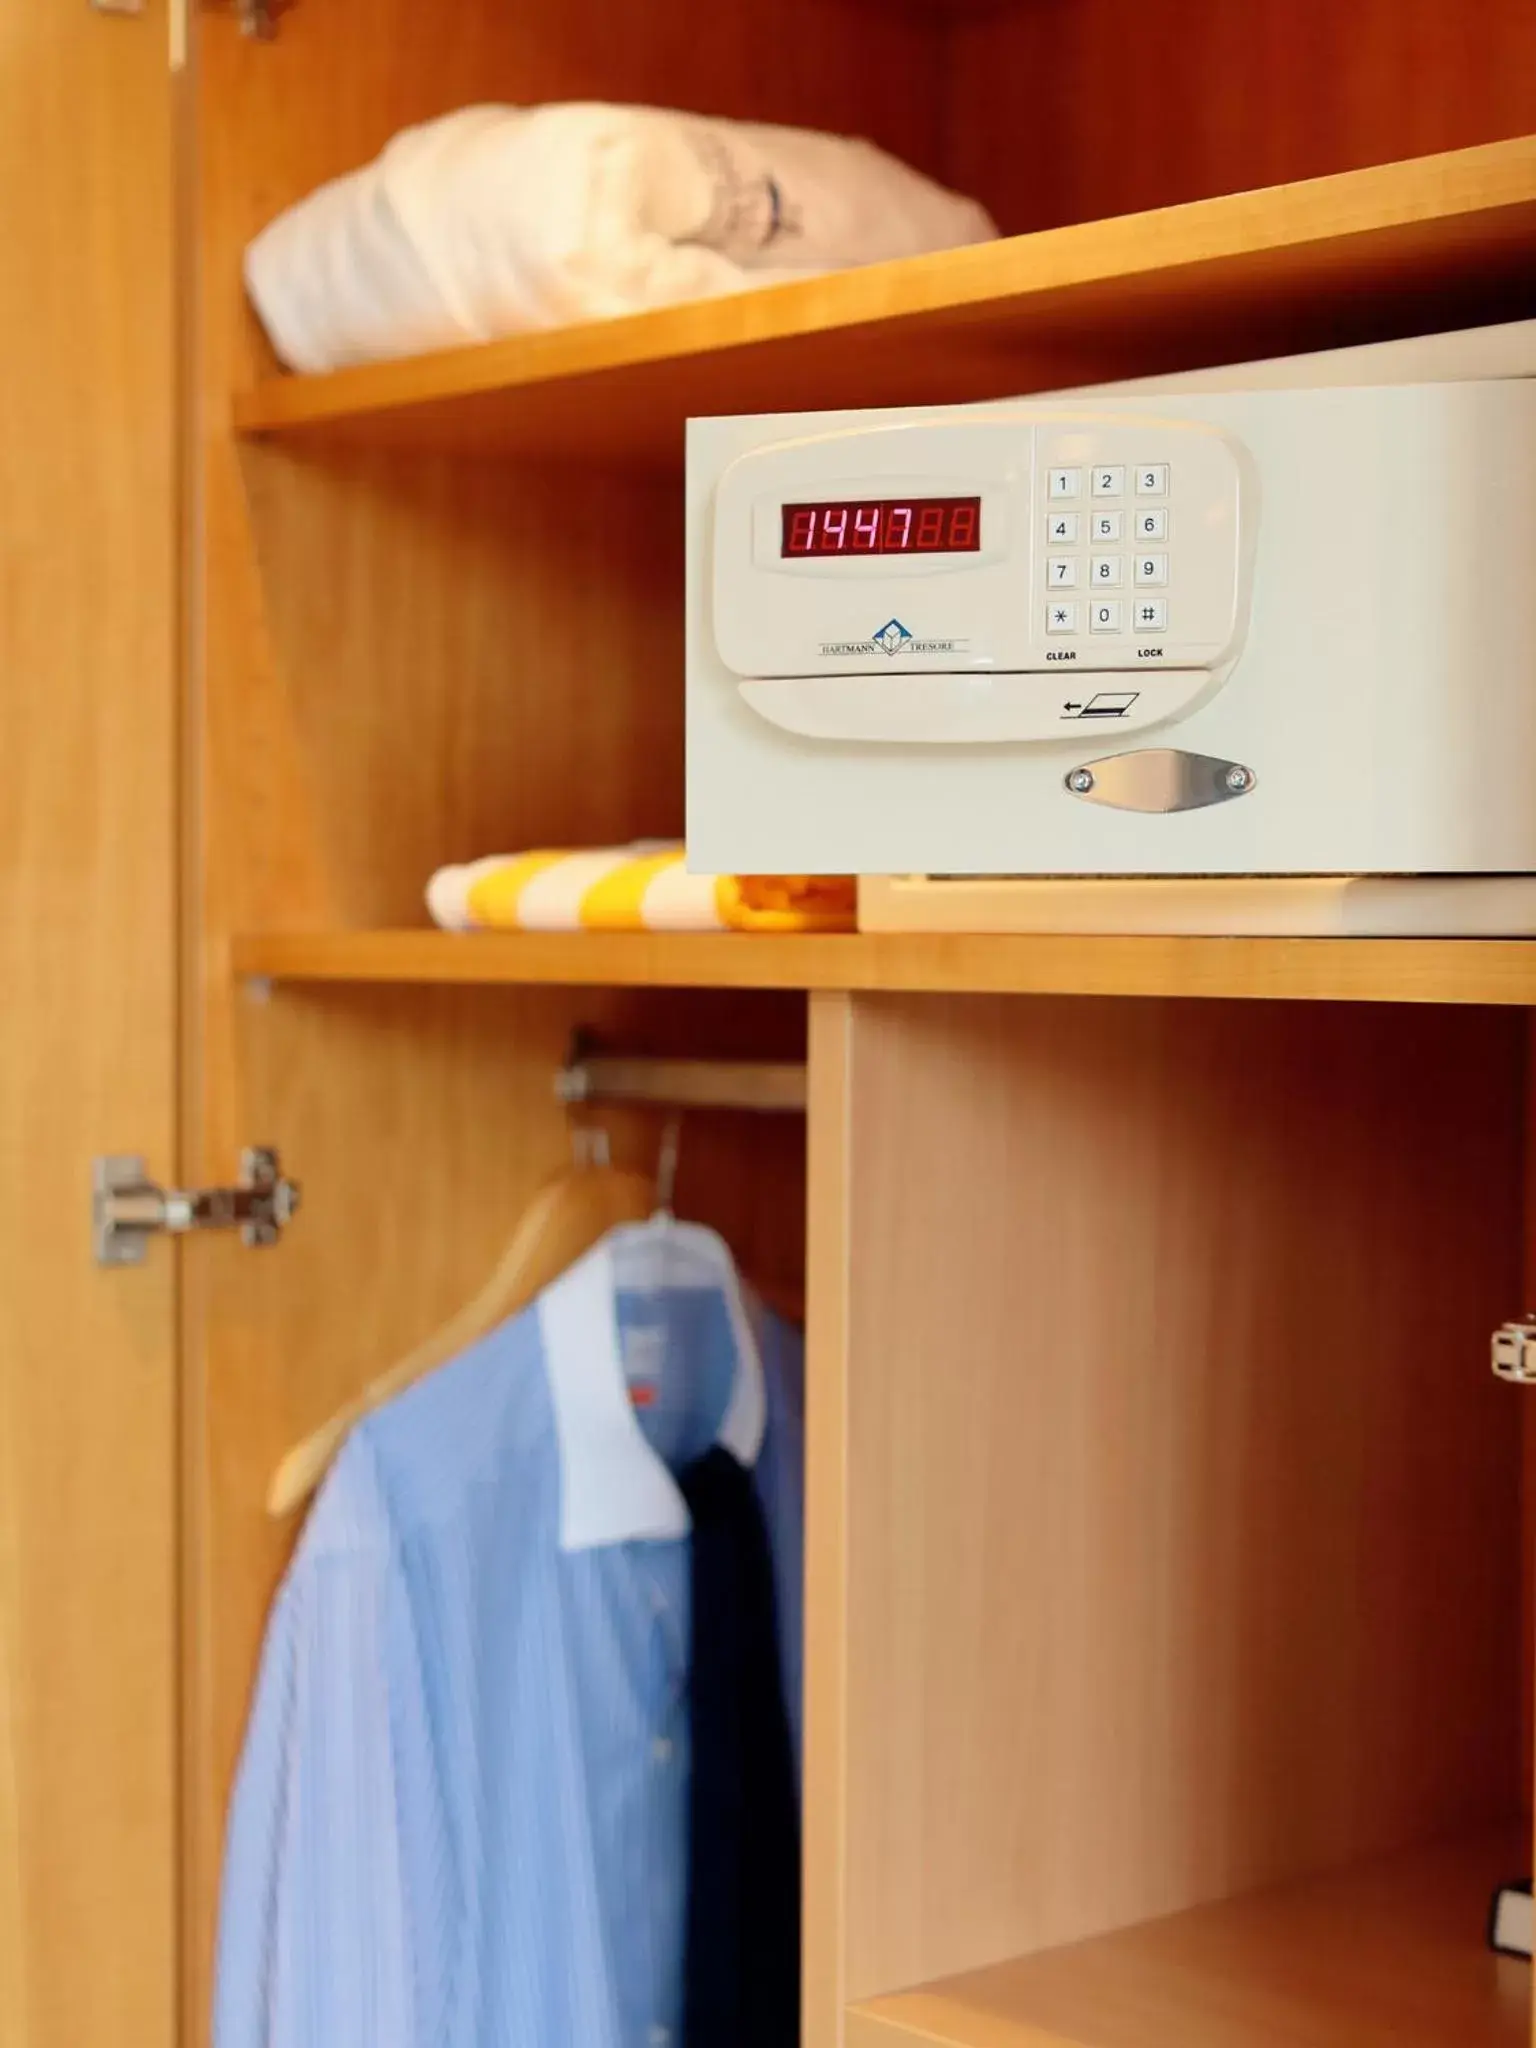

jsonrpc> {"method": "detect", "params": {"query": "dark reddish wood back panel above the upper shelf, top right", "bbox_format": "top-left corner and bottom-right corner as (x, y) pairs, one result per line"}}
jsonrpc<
(946, 0), (1536, 233)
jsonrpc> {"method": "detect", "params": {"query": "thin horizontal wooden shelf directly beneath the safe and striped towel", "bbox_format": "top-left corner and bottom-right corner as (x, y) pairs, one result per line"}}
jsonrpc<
(231, 932), (1536, 1004)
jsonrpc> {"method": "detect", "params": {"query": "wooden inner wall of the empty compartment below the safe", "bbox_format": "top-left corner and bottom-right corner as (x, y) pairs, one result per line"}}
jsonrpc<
(811, 997), (1522, 1999)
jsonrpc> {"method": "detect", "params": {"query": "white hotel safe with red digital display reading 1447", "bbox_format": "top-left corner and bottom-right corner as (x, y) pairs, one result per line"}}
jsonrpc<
(688, 322), (1536, 930)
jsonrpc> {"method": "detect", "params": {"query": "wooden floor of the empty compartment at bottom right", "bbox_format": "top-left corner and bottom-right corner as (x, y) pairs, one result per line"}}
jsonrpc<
(848, 1831), (1530, 2048)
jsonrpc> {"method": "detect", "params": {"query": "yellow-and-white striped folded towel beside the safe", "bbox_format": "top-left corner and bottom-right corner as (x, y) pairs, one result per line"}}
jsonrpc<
(426, 846), (858, 932)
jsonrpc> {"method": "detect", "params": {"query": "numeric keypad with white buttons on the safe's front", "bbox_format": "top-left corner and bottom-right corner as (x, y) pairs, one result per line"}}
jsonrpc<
(1044, 463), (1169, 637)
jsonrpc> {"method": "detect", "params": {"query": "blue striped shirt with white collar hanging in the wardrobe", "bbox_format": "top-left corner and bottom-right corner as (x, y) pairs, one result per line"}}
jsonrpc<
(213, 1225), (803, 2048)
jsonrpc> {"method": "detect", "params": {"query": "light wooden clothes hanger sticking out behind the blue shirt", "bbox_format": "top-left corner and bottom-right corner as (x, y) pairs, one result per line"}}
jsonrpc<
(266, 1133), (657, 1520)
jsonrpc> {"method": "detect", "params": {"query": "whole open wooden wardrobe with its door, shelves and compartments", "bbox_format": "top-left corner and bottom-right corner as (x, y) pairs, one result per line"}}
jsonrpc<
(0, 0), (1536, 2048)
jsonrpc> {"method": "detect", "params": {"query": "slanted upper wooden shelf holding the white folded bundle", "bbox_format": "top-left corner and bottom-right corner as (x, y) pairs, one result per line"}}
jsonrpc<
(233, 137), (1536, 465)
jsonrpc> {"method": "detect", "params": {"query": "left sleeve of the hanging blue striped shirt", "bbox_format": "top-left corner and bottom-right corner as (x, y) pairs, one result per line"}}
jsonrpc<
(213, 1444), (420, 2048)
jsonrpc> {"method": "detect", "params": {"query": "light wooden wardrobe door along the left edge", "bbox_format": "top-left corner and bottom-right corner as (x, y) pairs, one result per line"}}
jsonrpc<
(0, 0), (176, 2048)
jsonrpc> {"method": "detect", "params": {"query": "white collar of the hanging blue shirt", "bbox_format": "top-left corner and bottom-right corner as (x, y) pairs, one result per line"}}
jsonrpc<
(539, 1221), (768, 1550)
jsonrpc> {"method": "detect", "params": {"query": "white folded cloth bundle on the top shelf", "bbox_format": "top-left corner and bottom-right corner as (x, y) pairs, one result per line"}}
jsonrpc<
(246, 104), (997, 371)
